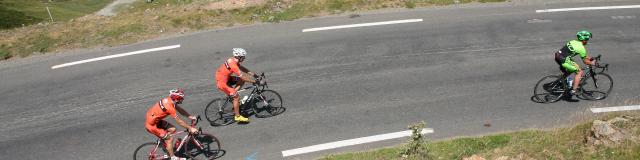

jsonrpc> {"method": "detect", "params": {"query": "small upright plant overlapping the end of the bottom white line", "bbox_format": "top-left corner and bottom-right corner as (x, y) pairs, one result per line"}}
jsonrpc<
(400, 121), (430, 159)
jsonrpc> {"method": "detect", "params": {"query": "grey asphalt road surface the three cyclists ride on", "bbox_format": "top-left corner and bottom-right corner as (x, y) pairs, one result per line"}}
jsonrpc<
(0, 0), (640, 160)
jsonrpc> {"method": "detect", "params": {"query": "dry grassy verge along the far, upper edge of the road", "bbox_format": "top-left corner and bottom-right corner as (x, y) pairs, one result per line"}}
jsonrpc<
(0, 0), (504, 60)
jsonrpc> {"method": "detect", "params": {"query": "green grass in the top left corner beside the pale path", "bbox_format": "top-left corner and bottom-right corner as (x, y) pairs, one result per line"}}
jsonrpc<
(0, 0), (113, 29)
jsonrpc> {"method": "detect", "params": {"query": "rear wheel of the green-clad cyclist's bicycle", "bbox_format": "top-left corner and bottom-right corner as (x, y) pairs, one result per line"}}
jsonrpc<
(533, 75), (567, 103)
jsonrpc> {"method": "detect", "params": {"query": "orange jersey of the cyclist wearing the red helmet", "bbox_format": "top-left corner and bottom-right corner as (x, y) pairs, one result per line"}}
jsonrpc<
(146, 97), (178, 126)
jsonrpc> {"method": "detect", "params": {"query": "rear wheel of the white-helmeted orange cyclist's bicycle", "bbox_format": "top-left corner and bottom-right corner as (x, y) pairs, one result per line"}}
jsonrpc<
(204, 98), (235, 126)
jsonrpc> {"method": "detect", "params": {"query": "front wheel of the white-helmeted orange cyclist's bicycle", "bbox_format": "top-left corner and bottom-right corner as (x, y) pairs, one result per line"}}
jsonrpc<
(253, 90), (285, 118)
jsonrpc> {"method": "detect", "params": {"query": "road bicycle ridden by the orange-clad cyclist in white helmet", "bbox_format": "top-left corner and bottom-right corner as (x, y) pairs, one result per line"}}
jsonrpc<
(204, 73), (286, 126)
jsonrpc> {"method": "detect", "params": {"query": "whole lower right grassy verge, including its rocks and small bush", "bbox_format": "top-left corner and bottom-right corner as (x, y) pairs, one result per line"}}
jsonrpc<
(321, 112), (640, 160)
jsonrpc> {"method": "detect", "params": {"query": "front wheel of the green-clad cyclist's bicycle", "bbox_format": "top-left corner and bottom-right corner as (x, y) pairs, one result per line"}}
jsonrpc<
(581, 73), (613, 100)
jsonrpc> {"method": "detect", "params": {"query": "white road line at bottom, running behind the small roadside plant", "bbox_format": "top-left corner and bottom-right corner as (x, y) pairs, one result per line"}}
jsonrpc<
(282, 128), (433, 157)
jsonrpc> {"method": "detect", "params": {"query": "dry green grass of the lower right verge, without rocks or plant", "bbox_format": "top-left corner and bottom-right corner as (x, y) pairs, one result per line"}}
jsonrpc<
(321, 112), (640, 160)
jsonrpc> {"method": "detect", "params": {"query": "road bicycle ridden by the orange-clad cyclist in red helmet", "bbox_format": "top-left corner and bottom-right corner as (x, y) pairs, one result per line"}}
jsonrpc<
(133, 116), (224, 160)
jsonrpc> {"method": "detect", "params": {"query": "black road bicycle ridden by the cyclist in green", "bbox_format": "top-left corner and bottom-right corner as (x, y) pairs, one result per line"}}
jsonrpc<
(533, 55), (613, 103)
